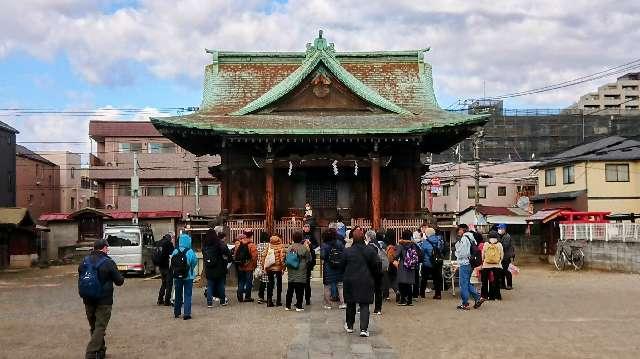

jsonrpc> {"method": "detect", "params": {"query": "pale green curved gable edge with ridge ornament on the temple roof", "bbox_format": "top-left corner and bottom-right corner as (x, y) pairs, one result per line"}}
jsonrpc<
(231, 32), (411, 116)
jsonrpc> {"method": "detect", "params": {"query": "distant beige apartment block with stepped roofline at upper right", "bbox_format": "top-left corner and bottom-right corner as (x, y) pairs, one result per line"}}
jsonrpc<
(571, 72), (640, 114)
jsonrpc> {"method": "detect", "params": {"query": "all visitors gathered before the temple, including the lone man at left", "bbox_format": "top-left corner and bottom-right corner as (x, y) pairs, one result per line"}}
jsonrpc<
(78, 221), (515, 358)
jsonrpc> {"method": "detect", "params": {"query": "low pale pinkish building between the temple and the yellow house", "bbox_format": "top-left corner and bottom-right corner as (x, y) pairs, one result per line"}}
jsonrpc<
(421, 162), (538, 212)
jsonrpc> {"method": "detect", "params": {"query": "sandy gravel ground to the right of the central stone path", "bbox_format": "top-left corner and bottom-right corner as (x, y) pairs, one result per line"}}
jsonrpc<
(380, 266), (640, 359)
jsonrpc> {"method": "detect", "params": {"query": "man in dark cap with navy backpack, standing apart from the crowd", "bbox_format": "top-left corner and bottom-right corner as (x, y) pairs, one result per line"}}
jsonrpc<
(78, 239), (124, 359)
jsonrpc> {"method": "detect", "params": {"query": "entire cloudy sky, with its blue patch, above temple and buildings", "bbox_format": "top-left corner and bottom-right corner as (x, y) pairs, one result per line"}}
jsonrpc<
(0, 0), (640, 156)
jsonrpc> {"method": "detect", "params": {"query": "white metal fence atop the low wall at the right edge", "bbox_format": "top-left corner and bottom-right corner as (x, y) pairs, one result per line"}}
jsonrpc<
(560, 223), (640, 242)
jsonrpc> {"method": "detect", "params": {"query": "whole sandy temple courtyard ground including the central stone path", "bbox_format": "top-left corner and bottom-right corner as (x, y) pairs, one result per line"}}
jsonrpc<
(0, 266), (640, 359)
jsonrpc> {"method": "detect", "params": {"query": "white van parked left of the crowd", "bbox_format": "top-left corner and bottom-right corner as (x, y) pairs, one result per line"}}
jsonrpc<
(104, 224), (155, 276)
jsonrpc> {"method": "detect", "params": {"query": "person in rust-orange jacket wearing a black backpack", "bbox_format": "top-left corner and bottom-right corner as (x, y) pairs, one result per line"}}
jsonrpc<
(233, 230), (258, 303)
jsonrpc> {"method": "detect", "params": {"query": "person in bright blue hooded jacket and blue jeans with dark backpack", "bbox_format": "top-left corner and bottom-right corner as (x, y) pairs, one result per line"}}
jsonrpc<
(171, 233), (198, 320)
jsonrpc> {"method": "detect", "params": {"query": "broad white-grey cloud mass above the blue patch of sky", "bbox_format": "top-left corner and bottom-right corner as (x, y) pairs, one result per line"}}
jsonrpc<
(0, 0), (640, 106)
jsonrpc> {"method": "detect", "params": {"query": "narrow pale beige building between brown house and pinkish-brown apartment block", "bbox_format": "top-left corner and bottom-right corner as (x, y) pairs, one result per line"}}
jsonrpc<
(38, 151), (98, 213)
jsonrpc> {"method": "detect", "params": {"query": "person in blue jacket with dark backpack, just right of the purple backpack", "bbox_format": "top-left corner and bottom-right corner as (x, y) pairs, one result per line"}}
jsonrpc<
(420, 227), (444, 299)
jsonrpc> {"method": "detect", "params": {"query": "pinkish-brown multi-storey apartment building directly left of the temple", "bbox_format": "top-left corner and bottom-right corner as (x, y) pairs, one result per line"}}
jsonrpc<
(89, 121), (220, 216)
